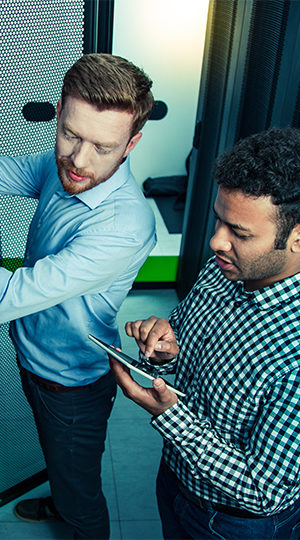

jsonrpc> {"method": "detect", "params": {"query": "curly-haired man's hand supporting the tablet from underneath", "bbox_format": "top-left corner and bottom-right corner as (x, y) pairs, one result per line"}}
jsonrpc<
(109, 355), (178, 416)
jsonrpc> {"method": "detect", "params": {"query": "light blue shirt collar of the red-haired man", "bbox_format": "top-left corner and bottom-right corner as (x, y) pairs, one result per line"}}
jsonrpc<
(57, 157), (130, 210)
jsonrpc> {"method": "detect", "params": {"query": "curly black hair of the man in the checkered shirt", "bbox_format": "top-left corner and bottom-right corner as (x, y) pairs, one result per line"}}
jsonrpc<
(214, 127), (300, 249)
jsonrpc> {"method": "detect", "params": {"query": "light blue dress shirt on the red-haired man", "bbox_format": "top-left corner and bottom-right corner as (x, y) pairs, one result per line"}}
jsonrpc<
(0, 151), (156, 386)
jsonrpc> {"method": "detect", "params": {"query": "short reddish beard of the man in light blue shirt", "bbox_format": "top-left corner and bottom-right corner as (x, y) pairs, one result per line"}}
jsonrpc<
(55, 151), (123, 195)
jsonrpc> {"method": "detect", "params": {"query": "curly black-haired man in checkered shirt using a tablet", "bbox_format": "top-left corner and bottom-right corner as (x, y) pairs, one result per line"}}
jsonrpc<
(111, 128), (300, 540)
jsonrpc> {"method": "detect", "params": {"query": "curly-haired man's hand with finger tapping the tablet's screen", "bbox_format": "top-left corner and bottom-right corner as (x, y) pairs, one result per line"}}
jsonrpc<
(125, 317), (178, 364)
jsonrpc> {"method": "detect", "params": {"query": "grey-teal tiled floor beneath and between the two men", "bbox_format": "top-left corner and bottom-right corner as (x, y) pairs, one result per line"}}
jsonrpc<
(0, 290), (177, 540)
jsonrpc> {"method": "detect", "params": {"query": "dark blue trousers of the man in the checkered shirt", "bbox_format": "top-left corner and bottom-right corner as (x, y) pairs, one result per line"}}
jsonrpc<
(157, 461), (300, 540)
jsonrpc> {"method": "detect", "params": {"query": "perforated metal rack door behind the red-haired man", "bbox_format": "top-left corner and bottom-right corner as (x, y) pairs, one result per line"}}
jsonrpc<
(0, 0), (84, 505)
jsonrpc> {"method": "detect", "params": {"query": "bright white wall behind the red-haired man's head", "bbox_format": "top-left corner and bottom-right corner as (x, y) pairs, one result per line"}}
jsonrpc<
(113, 0), (209, 184)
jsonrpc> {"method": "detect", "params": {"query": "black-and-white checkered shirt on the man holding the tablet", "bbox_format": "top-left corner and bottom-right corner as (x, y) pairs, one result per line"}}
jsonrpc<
(151, 259), (300, 515)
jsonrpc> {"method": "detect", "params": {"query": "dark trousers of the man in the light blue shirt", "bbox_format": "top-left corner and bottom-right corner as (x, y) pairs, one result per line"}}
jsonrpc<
(21, 364), (116, 540)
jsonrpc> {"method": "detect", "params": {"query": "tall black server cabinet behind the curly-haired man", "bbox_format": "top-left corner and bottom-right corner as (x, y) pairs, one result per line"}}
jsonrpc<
(177, 0), (300, 298)
